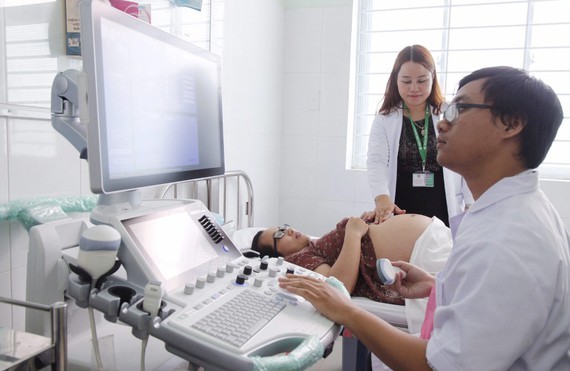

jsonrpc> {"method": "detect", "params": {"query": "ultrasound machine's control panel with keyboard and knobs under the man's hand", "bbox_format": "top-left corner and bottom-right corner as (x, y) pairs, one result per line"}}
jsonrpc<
(161, 257), (335, 354)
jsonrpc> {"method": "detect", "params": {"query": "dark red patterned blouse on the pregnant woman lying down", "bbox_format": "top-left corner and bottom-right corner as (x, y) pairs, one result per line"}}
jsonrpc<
(285, 218), (404, 305)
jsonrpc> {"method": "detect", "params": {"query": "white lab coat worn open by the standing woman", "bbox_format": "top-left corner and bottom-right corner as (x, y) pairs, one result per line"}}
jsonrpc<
(366, 109), (473, 218)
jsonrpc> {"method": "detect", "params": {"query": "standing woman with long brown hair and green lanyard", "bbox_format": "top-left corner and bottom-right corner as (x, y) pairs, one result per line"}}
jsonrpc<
(362, 45), (472, 226)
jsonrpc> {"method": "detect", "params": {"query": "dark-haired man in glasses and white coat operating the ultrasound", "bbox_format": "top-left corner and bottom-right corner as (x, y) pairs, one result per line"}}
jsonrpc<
(281, 67), (570, 370)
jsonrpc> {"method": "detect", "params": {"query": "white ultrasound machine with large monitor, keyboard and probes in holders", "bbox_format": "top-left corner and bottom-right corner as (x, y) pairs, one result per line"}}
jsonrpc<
(27, 0), (341, 370)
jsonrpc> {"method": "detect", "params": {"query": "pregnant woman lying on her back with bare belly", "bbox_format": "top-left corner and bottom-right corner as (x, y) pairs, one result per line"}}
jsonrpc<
(248, 214), (452, 304)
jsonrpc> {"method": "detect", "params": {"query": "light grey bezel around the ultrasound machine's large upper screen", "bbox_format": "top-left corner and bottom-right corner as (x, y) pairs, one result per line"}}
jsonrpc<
(80, 1), (225, 194)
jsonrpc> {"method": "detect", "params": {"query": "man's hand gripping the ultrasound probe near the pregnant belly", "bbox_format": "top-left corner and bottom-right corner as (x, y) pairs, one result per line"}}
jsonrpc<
(392, 261), (435, 299)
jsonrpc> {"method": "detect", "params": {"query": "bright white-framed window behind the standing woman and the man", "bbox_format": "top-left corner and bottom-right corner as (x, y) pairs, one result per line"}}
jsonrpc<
(347, 0), (570, 179)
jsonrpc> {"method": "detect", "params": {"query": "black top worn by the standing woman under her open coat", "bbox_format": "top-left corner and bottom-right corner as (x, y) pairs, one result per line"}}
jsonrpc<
(395, 116), (449, 227)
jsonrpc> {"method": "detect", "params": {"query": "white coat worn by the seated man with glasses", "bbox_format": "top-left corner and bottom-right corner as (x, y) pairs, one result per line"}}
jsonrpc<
(427, 171), (570, 370)
